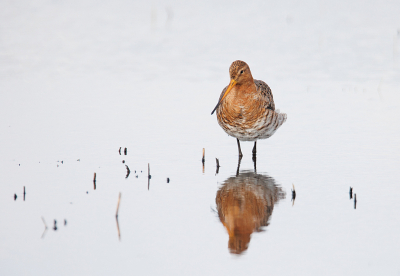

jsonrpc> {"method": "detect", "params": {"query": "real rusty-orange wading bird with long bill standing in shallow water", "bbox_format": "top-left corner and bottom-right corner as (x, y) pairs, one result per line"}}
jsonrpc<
(211, 60), (287, 157)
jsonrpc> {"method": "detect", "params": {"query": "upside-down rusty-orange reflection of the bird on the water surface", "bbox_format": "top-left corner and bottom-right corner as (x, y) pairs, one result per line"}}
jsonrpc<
(215, 171), (285, 254)
